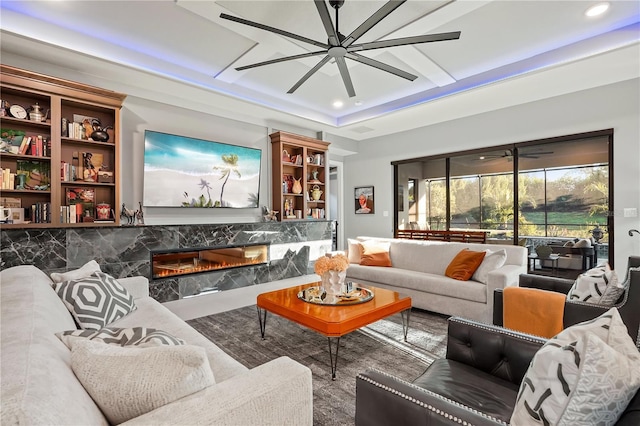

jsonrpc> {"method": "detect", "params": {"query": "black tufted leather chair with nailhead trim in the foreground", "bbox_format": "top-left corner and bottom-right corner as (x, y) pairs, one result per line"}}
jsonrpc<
(355, 317), (640, 426)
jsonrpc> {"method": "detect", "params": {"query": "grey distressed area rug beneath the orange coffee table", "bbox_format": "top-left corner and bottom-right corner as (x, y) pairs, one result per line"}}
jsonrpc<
(187, 305), (447, 426)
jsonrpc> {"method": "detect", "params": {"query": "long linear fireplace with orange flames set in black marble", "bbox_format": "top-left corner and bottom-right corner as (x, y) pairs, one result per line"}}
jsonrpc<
(151, 243), (269, 280)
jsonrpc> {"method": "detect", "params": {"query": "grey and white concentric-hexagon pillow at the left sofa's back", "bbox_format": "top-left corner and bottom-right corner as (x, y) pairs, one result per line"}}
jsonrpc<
(53, 272), (136, 330)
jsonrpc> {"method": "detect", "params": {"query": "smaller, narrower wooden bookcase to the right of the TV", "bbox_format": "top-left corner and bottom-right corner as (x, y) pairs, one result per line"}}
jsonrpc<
(269, 132), (329, 221)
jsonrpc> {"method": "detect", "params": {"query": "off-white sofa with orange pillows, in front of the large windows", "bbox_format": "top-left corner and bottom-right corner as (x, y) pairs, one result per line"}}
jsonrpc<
(346, 237), (527, 323)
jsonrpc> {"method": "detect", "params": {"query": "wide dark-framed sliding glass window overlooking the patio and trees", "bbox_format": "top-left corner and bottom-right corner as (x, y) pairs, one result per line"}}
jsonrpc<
(393, 130), (613, 259)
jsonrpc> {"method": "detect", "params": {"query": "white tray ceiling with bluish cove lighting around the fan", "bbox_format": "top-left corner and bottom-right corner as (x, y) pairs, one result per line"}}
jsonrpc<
(0, 0), (640, 136)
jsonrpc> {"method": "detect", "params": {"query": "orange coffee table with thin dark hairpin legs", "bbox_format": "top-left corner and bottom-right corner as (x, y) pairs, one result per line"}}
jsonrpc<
(257, 282), (411, 380)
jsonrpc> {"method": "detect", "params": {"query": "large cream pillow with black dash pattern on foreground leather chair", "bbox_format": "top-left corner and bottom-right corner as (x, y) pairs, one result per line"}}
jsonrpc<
(510, 308), (640, 426)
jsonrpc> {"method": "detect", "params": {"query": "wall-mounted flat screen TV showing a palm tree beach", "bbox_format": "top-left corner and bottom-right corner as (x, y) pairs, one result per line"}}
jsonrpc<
(143, 130), (262, 208)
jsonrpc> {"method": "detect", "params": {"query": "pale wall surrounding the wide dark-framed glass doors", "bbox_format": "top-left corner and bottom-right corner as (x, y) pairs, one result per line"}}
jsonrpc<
(344, 79), (640, 267)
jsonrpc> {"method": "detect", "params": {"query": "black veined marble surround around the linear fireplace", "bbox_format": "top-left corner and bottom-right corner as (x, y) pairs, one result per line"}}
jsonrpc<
(0, 220), (332, 302)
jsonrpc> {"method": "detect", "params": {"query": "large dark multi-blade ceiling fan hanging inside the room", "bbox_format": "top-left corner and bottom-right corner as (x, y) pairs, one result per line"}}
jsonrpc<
(220, 0), (460, 97)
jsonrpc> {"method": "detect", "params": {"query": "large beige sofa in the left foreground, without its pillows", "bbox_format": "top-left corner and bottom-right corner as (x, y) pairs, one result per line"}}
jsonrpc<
(0, 266), (313, 426)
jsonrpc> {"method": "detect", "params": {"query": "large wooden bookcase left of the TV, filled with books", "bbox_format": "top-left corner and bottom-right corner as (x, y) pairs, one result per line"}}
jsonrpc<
(0, 65), (126, 228)
